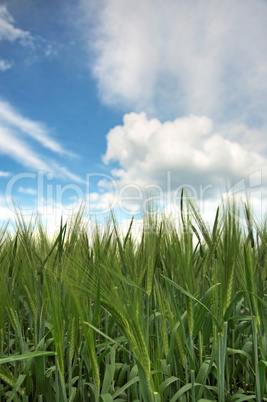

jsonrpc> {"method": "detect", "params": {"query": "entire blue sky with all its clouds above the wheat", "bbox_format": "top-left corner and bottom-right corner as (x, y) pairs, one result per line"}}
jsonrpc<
(0, 0), (267, 231)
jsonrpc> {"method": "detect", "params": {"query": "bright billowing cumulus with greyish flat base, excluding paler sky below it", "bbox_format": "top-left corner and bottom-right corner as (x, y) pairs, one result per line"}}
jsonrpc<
(103, 113), (267, 192)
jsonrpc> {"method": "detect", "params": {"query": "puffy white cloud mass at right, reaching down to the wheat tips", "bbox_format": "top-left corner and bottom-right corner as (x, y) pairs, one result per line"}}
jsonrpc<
(97, 113), (267, 224)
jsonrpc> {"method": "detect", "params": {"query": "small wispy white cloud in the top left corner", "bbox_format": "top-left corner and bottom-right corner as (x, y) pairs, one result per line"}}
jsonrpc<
(0, 5), (33, 46)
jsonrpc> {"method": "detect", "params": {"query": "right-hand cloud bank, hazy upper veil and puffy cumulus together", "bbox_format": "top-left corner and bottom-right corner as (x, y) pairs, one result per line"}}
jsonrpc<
(83, 0), (267, 217)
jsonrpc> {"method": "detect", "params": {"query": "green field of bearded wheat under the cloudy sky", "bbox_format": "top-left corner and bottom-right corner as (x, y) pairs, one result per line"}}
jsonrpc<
(0, 196), (267, 402)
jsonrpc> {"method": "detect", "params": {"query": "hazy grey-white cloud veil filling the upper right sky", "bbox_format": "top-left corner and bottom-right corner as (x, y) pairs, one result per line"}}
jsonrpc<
(88, 0), (267, 120)
